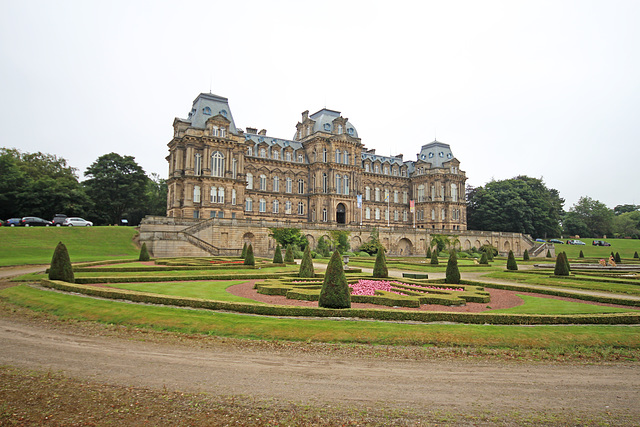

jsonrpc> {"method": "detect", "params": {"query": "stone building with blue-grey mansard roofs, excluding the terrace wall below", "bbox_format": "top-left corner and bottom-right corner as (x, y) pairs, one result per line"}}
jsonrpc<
(167, 93), (467, 233)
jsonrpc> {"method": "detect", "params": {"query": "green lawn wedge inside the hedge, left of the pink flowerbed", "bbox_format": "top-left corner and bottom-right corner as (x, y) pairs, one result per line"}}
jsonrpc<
(102, 280), (262, 304)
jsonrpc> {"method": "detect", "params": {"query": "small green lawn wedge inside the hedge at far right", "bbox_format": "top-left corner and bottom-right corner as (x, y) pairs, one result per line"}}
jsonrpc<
(491, 295), (633, 314)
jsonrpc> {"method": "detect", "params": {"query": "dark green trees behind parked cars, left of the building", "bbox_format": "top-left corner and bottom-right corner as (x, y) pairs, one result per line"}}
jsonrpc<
(0, 148), (167, 225)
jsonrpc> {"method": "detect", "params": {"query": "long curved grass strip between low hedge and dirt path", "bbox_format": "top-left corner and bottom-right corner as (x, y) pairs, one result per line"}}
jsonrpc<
(0, 285), (640, 350)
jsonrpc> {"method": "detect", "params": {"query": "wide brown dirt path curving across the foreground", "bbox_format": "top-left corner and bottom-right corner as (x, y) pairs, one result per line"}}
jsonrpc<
(0, 318), (640, 417)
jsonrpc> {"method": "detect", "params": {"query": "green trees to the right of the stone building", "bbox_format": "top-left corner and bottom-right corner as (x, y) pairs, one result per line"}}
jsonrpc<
(466, 176), (640, 239)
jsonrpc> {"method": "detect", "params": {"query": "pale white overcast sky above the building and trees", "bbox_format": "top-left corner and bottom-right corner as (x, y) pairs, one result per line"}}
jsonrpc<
(0, 0), (640, 210)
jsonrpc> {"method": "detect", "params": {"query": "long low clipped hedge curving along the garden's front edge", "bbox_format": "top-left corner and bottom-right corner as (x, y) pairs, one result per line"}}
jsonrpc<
(40, 280), (640, 325)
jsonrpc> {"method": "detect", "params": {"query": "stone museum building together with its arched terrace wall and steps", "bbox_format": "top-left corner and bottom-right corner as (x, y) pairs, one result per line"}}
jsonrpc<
(141, 93), (533, 256)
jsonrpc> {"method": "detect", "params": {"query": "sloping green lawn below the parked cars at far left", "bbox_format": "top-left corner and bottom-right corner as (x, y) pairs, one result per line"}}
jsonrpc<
(0, 227), (140, 266)
